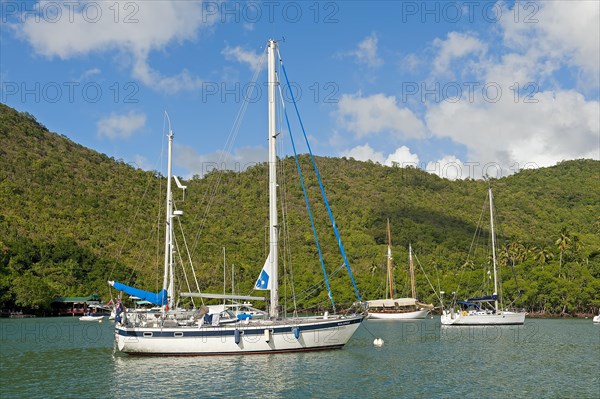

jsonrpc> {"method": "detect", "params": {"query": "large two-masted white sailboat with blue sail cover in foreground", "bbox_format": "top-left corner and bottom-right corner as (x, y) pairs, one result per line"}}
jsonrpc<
(109, 40), (366, 355)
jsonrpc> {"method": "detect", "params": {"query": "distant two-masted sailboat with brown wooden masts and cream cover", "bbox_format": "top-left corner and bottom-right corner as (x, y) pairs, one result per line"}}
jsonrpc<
(367, 219), (433, 320)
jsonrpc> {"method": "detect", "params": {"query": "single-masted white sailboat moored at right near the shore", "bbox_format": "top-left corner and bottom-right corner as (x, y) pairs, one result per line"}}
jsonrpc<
(441, 187), (527, 326)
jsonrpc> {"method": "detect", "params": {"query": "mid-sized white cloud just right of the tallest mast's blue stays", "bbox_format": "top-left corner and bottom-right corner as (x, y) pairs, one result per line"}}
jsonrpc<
(336, 93), (426, 138)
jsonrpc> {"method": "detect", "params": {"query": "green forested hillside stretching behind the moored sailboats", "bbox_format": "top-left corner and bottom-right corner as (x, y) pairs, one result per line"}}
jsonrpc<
(0, 104), (600, 313)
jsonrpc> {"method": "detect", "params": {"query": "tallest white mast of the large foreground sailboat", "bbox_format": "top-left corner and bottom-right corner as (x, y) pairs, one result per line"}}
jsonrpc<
(267, 39), (279, 318)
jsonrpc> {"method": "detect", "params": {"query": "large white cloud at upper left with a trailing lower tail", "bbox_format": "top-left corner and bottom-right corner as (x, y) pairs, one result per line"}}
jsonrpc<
(11, 1), (217, 92)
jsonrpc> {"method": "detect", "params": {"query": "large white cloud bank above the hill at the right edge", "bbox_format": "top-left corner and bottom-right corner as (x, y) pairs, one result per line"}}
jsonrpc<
(427, 91), (600, 174)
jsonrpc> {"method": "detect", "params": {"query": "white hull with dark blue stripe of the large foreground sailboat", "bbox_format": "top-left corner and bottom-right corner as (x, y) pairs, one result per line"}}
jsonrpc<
(115, 315), (364, 355)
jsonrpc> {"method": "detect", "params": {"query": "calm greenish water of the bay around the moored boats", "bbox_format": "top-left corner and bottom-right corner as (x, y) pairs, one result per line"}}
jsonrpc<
(0, 318), (600, 399)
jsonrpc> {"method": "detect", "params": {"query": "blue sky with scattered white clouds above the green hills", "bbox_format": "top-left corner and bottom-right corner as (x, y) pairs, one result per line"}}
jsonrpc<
(0, 0), (600, 179)
